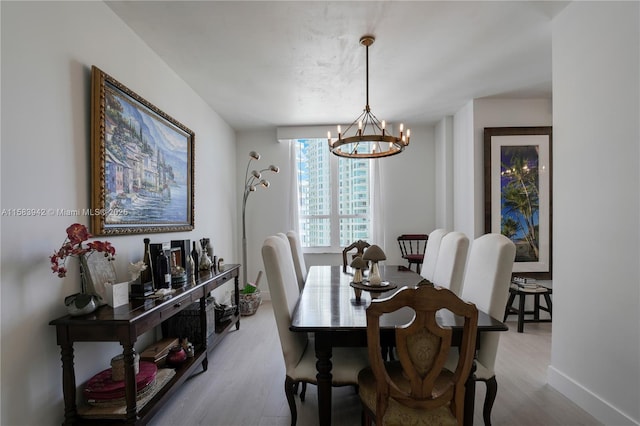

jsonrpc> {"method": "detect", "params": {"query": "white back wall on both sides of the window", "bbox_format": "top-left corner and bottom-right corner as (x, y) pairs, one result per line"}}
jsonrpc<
(236, 126), (435, 298)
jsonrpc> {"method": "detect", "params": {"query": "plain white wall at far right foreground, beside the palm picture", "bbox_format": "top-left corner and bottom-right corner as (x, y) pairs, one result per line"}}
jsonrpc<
(549, 2), (640, 425)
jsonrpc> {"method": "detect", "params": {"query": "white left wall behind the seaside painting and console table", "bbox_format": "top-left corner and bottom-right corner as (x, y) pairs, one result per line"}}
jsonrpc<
(0, 2), (237, 425)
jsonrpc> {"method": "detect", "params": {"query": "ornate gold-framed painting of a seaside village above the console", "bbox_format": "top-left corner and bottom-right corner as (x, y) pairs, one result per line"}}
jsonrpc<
(89, 66), (195, 235)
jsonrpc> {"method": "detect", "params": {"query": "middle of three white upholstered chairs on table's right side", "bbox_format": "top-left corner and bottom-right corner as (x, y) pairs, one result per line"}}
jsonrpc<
(431, 232), (469, 296)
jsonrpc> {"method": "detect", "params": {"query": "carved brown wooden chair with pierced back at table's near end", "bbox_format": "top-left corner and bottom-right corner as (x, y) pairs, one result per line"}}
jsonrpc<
(358, 285), (478, 426)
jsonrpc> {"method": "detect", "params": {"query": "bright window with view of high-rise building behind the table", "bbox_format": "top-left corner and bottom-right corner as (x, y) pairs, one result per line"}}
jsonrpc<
(296, 139), (372, 252)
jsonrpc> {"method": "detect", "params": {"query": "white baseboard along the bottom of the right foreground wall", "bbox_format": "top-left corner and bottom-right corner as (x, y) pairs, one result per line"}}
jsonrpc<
(547, 366), (640, 426)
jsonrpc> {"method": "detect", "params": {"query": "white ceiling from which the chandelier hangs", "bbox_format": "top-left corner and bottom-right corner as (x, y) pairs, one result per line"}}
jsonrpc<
(105, 1), (567, 130)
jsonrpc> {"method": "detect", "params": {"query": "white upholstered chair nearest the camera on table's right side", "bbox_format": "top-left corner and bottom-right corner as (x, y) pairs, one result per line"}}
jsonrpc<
(447, 234), (516, 426)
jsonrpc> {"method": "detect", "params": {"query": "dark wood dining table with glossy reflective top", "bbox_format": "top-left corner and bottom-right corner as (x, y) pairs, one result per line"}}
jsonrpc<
(290, 265), (508, 426)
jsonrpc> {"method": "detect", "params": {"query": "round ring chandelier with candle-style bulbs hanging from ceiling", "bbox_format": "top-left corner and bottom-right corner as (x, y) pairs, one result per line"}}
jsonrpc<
(327, 35), (411, 158)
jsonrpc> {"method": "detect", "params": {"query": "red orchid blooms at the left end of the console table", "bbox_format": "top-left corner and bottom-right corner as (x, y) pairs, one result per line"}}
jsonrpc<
(50, 223), (116, 278)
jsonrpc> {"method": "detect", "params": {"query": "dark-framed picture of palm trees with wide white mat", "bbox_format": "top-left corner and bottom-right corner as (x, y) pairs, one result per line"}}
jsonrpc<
(484, 127), (552, 279)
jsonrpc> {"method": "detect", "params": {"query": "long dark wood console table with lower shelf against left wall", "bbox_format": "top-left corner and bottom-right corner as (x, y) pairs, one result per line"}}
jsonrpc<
(49, 265), (240, 425)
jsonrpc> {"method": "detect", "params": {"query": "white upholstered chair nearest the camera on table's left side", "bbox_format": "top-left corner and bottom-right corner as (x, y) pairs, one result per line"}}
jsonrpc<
(262, 236), (368, 426)
